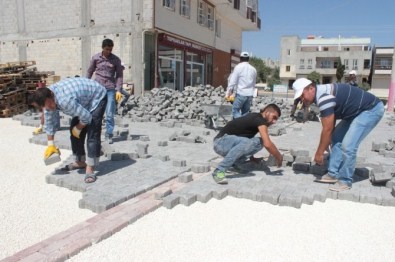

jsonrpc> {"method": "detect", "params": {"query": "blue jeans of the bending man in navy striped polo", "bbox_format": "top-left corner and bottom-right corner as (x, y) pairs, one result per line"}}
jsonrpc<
(328, 102), (384, 186)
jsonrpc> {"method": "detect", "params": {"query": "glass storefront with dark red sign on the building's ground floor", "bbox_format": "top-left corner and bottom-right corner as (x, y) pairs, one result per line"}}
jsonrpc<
(157, 33), (213, 91)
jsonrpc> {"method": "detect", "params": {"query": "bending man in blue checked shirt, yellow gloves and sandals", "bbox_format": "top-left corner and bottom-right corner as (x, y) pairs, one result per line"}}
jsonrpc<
(32, 77), (107, 183)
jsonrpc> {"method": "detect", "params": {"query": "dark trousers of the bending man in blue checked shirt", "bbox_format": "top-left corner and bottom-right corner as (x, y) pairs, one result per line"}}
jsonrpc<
(70, 97), (107, 161)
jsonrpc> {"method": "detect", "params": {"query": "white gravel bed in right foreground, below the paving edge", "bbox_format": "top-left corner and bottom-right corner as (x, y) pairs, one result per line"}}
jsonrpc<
(71, 197), (395, 261)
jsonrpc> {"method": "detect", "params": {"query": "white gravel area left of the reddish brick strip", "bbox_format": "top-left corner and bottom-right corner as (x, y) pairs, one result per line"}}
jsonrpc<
(0, 118), (95, 259)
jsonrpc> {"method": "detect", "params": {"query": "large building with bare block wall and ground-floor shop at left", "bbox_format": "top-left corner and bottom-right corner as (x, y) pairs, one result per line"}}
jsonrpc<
(0, 0), (260, 93)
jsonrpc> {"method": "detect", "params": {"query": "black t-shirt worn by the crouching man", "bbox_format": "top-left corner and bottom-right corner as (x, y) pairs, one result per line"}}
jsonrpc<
(214, 113), (269, 139)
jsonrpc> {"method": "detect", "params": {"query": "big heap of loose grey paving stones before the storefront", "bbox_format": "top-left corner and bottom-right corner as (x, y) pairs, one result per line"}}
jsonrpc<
(119, 85), (310, 127)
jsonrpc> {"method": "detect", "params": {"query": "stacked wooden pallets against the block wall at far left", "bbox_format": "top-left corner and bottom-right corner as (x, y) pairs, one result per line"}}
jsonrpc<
(0, 61), (55, 117)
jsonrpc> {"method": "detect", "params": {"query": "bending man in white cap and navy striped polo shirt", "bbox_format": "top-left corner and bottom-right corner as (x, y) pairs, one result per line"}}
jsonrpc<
(292, 78), (384, 192)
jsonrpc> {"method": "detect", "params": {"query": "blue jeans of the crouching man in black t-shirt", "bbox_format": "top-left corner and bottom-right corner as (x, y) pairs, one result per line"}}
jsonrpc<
(214, 135), (263, 172)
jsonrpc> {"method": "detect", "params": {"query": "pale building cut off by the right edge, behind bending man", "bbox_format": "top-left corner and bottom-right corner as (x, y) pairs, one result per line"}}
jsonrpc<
(370, 47), (394, 100)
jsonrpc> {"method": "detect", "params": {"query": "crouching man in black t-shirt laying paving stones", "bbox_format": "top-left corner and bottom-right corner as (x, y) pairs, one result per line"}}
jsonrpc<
(212, 104), (283, 184)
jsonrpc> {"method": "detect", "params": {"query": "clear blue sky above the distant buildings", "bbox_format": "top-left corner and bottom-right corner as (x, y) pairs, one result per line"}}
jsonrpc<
(242, 0), (395, 60)
